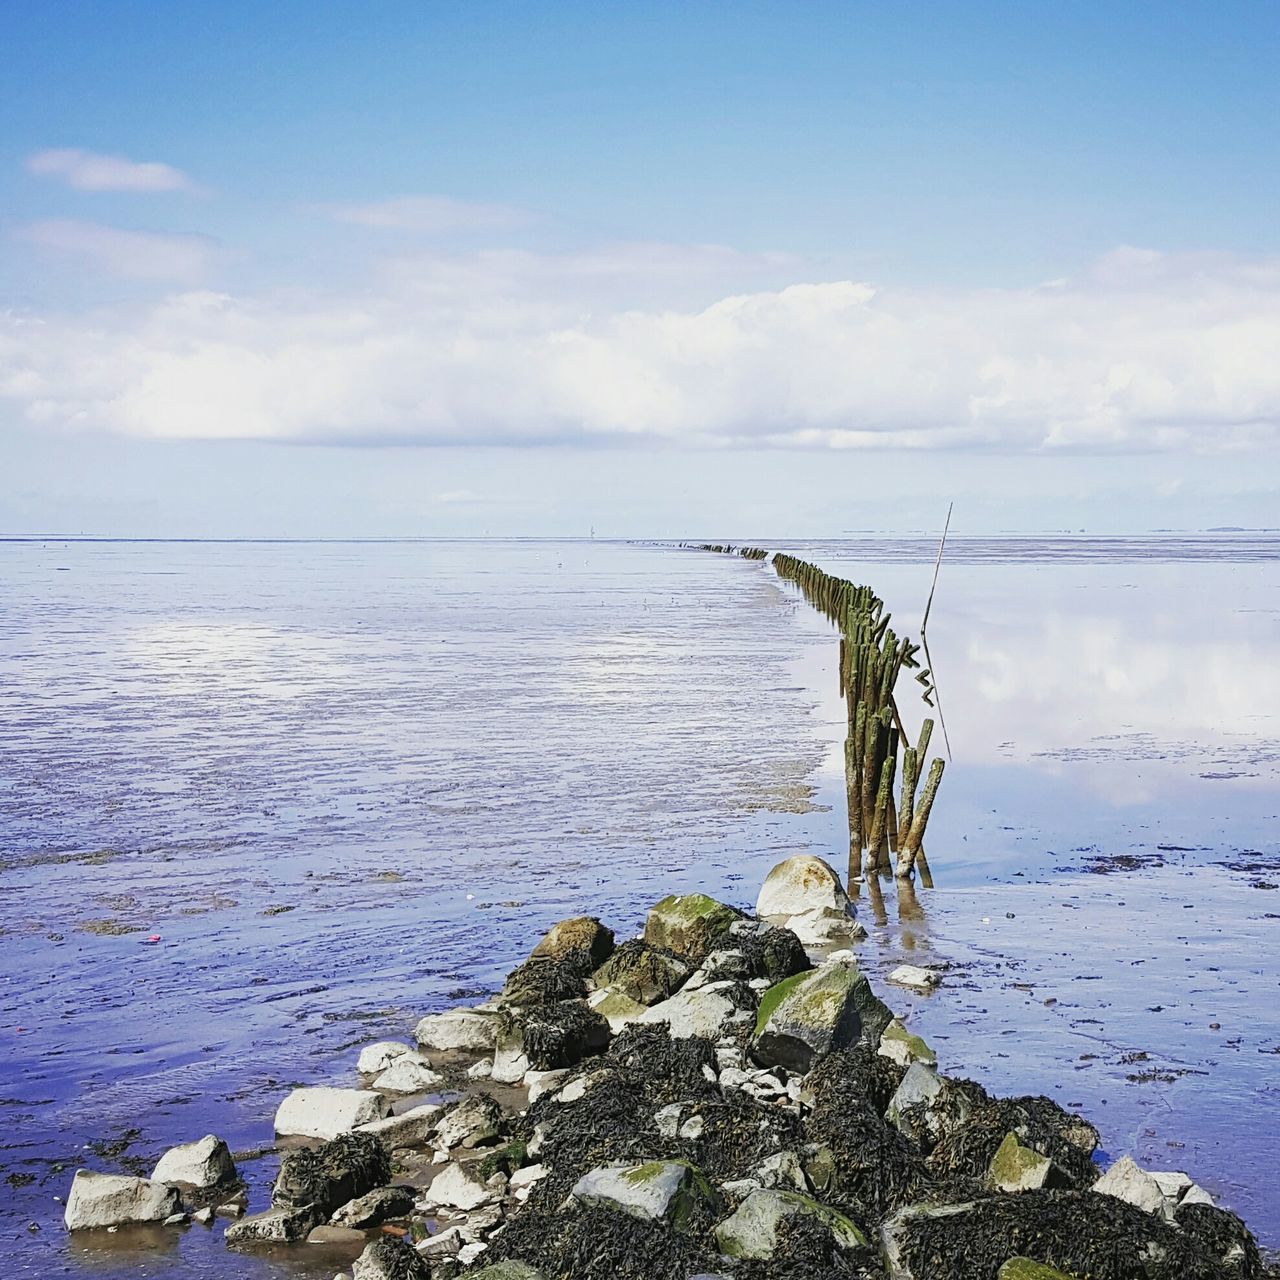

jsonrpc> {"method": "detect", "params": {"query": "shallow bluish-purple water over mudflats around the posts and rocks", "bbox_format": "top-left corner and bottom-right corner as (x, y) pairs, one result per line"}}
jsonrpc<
(0, 539), (1280, 1276)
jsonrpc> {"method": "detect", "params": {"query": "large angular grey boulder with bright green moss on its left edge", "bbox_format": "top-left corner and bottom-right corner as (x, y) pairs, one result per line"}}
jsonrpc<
(751, 961), (892, 1074)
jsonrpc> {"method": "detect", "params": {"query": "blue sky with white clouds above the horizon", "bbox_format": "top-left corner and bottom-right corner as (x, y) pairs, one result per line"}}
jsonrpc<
(0, 0), (1280, 538)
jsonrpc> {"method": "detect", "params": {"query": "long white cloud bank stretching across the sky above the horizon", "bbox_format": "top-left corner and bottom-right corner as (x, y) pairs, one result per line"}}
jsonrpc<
(0, 246), (1280, 452)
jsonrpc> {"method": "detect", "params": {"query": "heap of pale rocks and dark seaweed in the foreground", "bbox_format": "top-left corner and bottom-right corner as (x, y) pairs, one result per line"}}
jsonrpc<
(67, 856), (1280, 1280)
